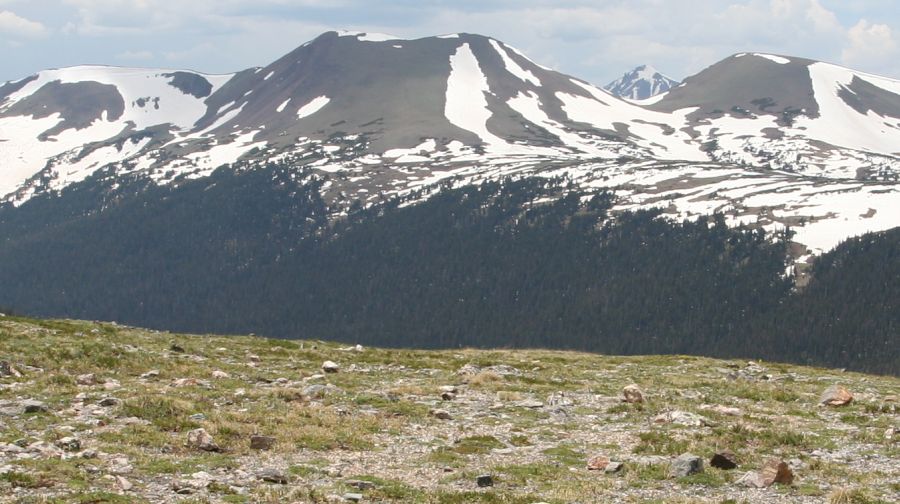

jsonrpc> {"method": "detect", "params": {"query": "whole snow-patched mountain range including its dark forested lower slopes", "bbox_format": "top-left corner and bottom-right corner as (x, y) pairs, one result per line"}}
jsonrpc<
(0, 32), (900, 372)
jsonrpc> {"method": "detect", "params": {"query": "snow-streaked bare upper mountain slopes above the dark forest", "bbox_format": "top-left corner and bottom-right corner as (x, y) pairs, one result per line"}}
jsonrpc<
(0, 36), (900, 258)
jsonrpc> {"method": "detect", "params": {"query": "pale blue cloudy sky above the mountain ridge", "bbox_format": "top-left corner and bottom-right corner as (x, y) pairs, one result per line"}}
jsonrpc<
(0, 0), (900, 85)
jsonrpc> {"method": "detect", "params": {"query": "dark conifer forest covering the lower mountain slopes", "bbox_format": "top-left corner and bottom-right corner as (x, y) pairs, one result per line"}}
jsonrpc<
(0, 165), (900, 374)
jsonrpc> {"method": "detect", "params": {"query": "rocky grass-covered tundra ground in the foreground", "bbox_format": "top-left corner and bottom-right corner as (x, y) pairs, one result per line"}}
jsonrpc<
(0, 315), (900, 504)
